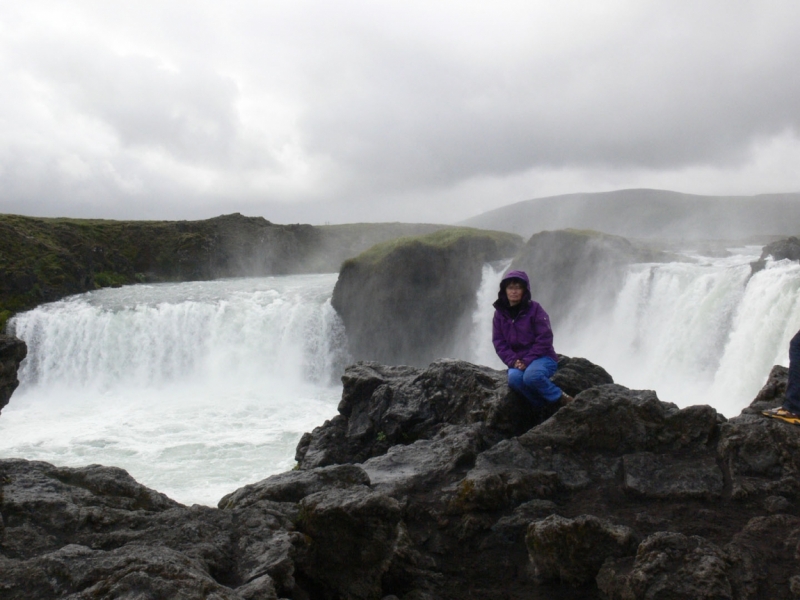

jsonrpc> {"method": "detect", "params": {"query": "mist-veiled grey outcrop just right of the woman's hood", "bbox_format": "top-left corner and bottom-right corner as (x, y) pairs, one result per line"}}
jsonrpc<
(510, 229), (672, 323)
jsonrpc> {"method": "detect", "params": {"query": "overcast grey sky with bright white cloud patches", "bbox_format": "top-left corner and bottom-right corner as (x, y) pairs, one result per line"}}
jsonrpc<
(0, 0), (800, 224)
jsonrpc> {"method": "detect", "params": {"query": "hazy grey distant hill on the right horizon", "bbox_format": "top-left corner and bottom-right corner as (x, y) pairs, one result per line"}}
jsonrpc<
(459, 189), (800, 240)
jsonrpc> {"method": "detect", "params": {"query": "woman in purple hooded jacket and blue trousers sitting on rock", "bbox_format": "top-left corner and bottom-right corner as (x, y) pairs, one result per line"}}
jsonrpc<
(492, 271), (572, 407)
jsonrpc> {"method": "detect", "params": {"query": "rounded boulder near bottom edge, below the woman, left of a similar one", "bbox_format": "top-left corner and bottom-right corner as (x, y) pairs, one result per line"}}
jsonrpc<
(525, 515), (636, 584)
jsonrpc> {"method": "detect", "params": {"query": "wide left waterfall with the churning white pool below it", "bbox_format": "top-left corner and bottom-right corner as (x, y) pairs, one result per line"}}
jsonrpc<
(0, 274), (347, 505)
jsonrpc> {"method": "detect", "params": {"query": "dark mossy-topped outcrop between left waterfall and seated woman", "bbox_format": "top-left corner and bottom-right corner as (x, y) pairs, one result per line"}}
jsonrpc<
(331, 229), (521, 365)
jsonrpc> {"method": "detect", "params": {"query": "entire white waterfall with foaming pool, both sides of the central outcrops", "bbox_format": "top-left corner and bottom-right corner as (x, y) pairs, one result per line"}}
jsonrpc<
(0, 247), (800, 505)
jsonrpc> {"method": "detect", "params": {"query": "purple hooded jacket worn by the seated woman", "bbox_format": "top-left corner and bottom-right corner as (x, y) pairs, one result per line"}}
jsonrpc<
(492, 271), (558, 367)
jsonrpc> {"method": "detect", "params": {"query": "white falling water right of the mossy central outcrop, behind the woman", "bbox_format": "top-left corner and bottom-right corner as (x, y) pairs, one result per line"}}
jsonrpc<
(465, 247), (800, 417)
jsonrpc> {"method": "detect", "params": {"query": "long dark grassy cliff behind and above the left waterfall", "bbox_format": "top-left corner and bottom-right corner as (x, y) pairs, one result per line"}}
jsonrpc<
(0, 214), (450, 329)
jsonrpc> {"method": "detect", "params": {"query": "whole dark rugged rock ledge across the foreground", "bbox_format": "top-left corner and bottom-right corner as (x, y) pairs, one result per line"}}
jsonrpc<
(0, 357), (800, 600)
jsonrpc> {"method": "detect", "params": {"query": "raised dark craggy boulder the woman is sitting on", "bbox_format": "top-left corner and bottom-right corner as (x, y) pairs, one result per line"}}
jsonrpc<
(295, 357), (611, 469)
